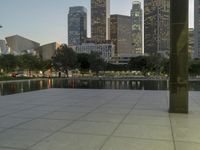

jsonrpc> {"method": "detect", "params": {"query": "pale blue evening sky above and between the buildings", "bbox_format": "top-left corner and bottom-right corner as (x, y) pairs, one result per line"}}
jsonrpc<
(0, 0), (194, 45)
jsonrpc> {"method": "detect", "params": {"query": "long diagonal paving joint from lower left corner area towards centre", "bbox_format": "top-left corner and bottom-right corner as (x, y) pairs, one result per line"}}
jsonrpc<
(27, 92), (124, 149)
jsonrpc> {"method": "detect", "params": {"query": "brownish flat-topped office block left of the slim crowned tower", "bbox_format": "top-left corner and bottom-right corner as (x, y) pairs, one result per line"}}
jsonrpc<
(110, 15), (134, 55)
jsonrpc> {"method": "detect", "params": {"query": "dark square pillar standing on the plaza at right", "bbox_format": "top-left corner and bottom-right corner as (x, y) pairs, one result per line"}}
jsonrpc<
(169, 0), (189, 113)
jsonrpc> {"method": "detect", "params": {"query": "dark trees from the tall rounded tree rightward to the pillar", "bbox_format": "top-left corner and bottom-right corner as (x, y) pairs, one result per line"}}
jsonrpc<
(52, 45), (169, 75)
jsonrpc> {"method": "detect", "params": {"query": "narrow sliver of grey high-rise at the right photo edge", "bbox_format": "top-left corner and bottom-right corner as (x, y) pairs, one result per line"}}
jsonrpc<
(193, 0), (200, 58)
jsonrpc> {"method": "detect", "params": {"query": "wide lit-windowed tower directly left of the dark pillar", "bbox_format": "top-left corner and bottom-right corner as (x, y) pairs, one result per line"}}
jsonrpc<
(144, 0), (170, 55)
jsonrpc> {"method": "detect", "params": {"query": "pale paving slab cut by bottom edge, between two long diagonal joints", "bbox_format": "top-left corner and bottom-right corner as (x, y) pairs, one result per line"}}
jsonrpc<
(31, 133), (106, 150)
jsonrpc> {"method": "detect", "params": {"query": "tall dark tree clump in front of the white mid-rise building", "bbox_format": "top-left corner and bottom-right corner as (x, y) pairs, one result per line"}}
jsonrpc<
(52, 45), (106, 75)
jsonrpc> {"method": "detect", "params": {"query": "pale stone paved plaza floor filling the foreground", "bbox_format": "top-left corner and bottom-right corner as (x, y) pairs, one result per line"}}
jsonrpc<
(0, 89), (200, 150)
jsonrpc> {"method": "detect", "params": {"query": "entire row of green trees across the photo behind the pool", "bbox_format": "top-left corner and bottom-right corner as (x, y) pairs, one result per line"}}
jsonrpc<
(0, 45), (200, 75)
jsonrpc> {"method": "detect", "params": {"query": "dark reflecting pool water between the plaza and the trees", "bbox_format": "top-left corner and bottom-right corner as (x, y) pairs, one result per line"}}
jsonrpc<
(0, 77), (200, 96)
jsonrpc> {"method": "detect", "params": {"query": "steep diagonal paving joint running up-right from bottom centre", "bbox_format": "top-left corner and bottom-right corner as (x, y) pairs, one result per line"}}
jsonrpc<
(99, 92), (145, 150)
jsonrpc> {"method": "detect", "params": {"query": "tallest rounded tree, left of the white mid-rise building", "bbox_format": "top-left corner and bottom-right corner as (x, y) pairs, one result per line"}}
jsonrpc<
(52, 44), (77, 77)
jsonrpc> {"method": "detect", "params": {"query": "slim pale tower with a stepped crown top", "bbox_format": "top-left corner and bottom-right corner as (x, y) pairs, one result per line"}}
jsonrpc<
(131, 1), (143, 54)
